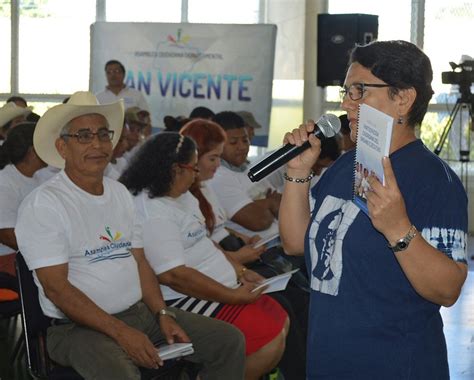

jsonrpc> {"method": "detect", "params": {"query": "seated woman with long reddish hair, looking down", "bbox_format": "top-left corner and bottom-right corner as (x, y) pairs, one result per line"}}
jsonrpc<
(180, 119), (309, 379)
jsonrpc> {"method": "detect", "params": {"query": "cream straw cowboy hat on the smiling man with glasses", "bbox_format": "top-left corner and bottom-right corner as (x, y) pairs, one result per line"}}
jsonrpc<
(33, 91), (124, 168)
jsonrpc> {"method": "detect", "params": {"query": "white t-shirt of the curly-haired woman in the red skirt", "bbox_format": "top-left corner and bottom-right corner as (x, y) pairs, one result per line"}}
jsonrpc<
(135, 191), (237, 300)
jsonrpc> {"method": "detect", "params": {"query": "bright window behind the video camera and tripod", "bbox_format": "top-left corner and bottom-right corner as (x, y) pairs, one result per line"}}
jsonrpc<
(422, 0), (474, 161)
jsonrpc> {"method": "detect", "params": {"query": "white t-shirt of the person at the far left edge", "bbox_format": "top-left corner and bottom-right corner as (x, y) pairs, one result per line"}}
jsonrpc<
(0, 165), (39, 256)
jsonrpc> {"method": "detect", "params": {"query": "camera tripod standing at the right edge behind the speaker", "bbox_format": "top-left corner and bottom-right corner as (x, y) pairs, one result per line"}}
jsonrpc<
(434, 86), (474, 191)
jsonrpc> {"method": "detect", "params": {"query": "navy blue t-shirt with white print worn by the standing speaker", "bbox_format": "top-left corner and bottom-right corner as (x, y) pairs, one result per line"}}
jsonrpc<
(305, 140), (467, 380)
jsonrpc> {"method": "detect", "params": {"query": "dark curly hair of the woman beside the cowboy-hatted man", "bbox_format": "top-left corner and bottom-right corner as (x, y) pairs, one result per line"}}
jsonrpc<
(119, 132), (196, 198)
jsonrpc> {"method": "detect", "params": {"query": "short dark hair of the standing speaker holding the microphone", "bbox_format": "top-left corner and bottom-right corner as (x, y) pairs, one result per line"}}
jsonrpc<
(349, 40), (434, 126)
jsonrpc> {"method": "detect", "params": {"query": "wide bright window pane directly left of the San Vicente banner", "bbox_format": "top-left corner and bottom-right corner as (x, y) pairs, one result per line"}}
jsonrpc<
(19, 0), (96, 94)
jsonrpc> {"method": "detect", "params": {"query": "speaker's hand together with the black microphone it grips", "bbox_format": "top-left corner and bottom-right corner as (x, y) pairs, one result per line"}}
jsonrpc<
(248, 114), (341, 182)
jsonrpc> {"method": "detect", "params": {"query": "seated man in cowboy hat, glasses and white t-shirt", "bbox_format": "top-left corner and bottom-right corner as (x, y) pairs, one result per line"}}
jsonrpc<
(15, 92), (245, 380)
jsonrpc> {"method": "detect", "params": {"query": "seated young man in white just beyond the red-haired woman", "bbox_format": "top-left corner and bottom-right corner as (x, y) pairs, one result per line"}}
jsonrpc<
(210, 111), (281, 236)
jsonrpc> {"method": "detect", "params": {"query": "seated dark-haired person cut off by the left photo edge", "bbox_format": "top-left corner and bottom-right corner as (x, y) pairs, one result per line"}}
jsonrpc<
(0, 122), (46, 274)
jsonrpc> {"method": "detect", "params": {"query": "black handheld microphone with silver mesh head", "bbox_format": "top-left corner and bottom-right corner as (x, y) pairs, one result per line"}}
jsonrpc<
(248, 113), (341, 182)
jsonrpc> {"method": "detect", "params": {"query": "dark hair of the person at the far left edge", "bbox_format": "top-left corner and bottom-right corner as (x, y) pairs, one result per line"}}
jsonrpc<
(0, 122), (36, 169)
